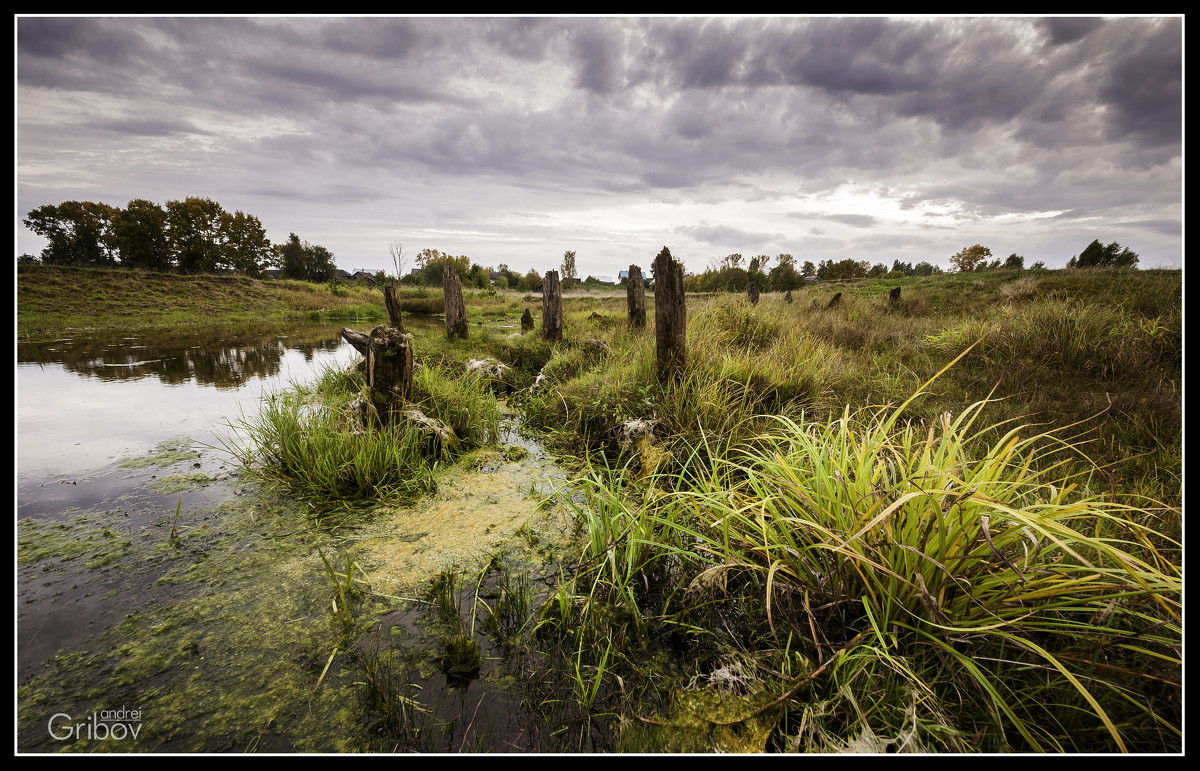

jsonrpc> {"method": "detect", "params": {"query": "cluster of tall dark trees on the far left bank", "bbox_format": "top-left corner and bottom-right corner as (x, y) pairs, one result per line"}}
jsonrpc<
(18, 197), (337, 281)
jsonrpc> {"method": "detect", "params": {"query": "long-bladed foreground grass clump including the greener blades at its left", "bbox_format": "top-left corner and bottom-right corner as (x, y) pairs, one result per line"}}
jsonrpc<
(549, 338), (1182, 752)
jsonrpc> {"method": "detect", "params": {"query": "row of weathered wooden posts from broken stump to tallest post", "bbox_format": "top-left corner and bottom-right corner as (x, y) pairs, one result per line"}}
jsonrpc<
(342, 246), (688, 418)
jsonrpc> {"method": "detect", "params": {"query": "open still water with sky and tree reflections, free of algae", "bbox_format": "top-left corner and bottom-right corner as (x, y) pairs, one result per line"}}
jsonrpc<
(17, 324), (359, 519)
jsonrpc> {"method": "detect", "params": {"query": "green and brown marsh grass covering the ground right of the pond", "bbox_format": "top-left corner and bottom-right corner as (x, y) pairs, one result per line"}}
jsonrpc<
(16, 265), (1183, 752)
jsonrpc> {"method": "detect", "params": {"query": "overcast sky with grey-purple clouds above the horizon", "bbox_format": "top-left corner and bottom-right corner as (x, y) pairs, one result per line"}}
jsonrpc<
(14, 17), (1183, 279)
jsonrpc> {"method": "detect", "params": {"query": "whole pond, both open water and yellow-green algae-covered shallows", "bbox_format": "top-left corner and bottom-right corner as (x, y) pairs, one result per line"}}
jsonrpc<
(14, 322), (578, 752)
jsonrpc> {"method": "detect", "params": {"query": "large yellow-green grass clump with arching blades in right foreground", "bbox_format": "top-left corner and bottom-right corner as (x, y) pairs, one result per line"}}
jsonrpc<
(638, 381), (1182, 752)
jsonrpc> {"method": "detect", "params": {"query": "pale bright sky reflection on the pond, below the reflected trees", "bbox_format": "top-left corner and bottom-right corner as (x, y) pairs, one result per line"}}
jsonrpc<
(16, 328), (358, 497)
